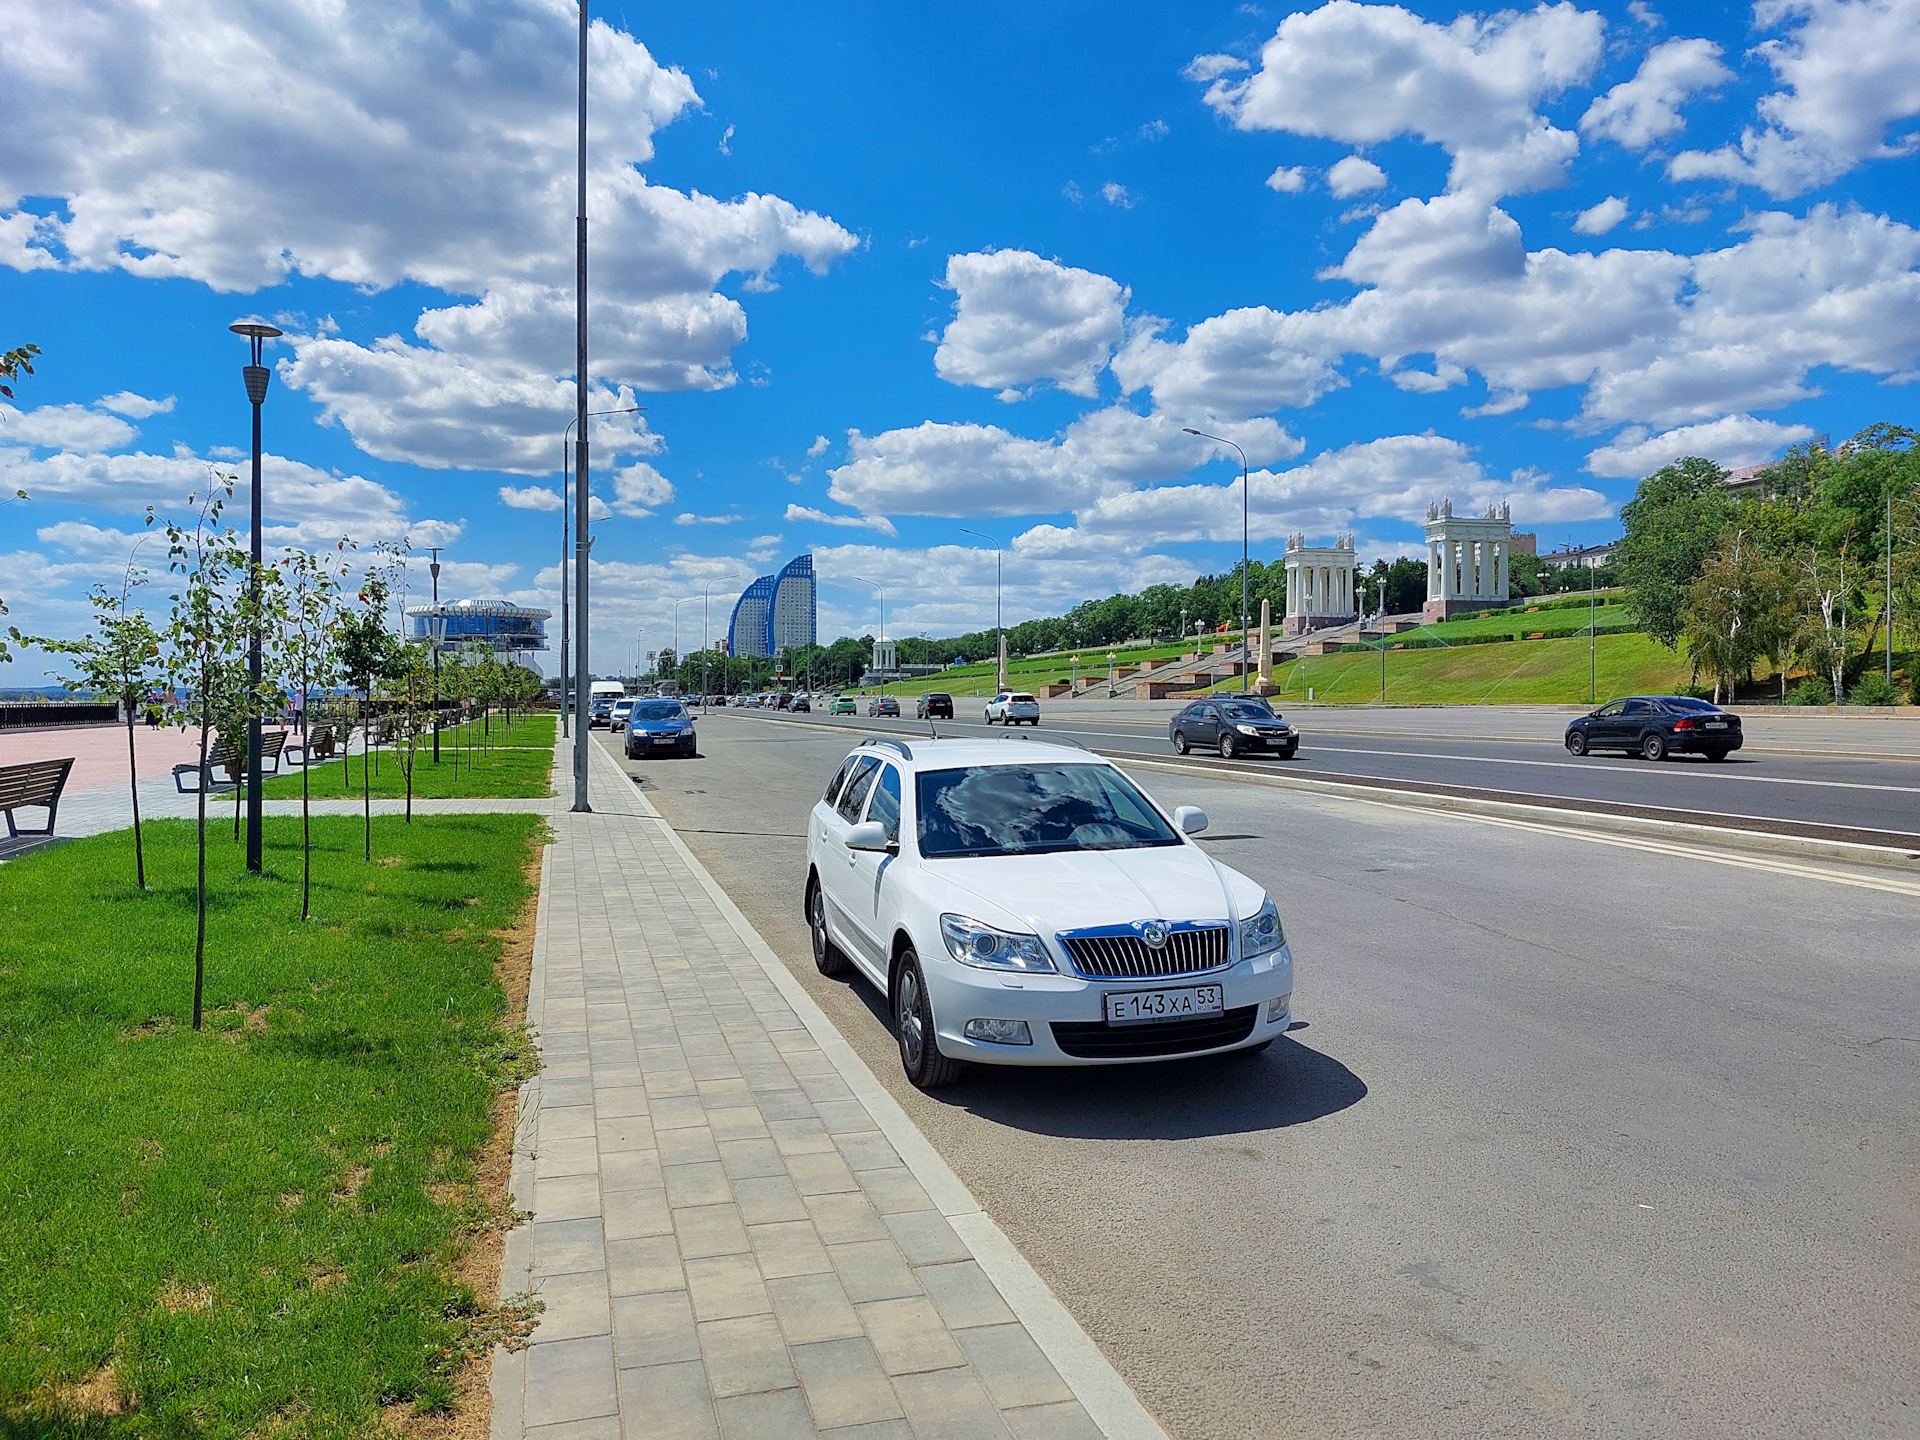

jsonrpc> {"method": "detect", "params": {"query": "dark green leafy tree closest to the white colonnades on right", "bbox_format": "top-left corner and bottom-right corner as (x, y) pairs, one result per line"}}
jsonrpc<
(1617, 455), (1734, 649)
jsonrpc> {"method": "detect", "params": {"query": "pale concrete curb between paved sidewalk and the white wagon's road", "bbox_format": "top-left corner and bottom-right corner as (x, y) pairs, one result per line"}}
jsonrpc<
(589, 737), (1167, 1440)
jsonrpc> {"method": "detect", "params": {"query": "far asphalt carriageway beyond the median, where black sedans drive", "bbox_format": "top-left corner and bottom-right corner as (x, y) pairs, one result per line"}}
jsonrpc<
(714, 703), (1920, 841)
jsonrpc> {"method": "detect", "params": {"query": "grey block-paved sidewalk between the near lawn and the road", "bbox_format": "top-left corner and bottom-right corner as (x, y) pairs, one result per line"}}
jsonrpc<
(493, 745), (1164, 1440)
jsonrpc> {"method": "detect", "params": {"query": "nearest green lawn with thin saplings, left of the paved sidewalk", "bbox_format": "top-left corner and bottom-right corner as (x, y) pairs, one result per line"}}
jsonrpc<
(0, 816), (543, 1436)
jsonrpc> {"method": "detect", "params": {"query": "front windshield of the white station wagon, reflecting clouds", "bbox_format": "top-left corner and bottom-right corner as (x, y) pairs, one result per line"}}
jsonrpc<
(914, 764), (1181, 860)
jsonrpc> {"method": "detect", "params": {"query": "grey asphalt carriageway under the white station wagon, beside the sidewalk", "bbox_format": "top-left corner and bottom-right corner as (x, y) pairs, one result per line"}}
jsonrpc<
(603, 714), (1920, 1440)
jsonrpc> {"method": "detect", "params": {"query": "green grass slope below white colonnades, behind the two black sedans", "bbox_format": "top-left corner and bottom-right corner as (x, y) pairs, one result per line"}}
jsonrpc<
(1244, 626), (1693, 705)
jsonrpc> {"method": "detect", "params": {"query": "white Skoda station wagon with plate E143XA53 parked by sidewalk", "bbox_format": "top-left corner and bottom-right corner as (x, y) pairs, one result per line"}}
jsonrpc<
(806, 735), (1294, 1089)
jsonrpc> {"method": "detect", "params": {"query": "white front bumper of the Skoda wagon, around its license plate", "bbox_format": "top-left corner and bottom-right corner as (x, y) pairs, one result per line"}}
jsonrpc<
(920, 945), (1294, 1066)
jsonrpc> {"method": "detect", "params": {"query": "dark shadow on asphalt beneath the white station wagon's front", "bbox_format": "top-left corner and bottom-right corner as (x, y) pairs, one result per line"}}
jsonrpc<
(935, 1037), (1367, 1140)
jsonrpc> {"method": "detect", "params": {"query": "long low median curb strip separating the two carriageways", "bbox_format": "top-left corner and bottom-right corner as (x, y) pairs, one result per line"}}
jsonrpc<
(714, 714), (1920, 876)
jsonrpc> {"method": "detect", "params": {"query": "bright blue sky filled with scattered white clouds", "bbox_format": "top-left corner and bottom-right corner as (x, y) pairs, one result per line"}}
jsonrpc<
(0, 0), (1920, 684)
